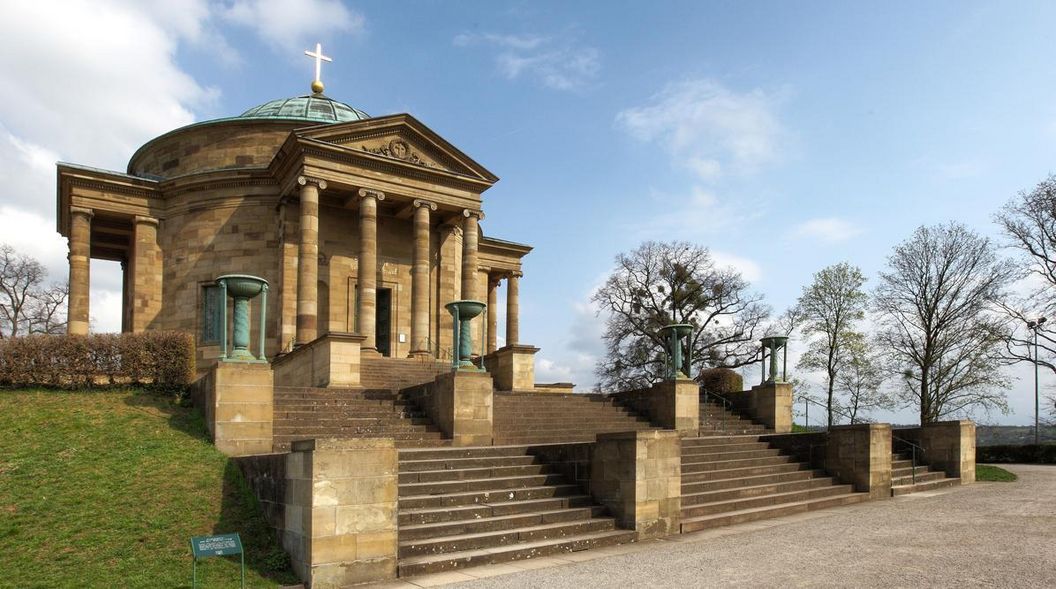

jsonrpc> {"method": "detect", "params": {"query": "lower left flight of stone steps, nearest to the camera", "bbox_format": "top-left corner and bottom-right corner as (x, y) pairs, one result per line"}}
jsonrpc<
(398, 447), (635, 576)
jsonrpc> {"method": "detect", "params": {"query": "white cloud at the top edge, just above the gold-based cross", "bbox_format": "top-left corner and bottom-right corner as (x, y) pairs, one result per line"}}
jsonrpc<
(221, 0), (364, 52)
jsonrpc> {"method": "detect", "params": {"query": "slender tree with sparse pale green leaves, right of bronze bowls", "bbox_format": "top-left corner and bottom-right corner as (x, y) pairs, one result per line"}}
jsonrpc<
(796, 266), (869, 426)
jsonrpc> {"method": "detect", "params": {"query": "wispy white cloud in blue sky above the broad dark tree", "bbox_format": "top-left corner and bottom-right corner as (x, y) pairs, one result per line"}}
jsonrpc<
(616, 79), (785, 181)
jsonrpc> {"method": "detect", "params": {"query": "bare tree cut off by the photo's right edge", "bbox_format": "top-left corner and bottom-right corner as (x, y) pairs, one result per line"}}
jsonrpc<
(995, 175), (1056, 374)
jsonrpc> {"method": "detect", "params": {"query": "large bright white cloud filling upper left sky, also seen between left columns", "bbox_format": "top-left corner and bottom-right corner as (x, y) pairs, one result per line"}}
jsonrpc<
(0, 0), (224, 330)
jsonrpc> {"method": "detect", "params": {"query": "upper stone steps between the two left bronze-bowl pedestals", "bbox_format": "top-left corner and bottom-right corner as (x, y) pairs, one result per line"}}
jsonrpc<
(272, 386), (450, 452)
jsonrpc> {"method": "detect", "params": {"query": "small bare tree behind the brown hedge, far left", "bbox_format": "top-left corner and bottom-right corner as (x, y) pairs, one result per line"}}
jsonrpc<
(0, 244), (69, 338)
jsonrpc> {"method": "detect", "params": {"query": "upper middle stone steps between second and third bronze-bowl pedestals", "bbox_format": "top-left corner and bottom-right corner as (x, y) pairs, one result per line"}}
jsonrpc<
(492, 392), (654, 444)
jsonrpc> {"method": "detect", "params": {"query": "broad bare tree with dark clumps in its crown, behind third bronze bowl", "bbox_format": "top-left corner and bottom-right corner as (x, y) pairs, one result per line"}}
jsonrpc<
(592, 242), (770, 391)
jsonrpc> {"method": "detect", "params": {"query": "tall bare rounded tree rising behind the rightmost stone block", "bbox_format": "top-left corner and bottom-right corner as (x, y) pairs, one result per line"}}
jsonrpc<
(873, 223), (1014, 423)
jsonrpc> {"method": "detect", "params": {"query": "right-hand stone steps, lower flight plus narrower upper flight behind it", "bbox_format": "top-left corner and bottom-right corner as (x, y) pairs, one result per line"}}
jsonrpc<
(681, 397), (868, 533)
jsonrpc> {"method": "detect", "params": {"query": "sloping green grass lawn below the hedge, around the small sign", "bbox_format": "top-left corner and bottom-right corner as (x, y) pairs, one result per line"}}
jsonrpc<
(0, 391), (297, 588)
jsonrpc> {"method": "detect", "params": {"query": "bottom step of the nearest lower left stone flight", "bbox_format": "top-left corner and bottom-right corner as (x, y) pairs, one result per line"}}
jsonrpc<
(398, 530), (635, 577)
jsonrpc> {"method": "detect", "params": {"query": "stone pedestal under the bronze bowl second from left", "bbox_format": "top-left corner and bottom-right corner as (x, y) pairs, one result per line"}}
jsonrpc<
(426, 372), (494, 445)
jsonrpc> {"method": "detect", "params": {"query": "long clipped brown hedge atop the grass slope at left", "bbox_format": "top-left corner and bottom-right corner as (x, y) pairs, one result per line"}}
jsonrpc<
(0, 331), (194, 388)
